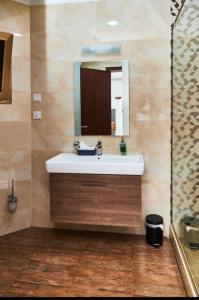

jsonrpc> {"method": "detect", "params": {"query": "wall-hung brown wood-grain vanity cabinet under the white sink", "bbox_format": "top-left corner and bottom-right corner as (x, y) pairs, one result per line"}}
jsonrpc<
(50, 173), (141, 227)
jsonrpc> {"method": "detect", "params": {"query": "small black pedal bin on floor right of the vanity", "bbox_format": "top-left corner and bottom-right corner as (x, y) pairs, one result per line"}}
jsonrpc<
(146, 214), (164, 248)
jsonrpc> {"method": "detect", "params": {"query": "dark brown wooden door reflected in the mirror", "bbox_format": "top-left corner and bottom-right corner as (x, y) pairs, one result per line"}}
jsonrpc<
(80, 68), (111, 135)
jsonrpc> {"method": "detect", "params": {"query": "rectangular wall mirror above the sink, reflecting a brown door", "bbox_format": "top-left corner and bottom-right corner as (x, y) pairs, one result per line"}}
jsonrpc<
(73, 60), (129, 136)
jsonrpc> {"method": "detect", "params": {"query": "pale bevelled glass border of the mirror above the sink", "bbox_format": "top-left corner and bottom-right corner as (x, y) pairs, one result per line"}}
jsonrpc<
(73, 59), (130, 137)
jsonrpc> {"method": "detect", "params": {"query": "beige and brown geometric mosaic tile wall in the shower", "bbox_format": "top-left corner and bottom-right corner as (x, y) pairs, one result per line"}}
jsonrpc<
(172, 0), (199, 232)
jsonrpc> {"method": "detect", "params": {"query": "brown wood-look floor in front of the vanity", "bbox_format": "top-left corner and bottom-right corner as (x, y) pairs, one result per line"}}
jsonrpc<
(0, 228), (185, 297)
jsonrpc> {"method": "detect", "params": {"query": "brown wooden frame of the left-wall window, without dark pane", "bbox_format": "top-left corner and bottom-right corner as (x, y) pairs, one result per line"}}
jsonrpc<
(0, 32), (13, 104)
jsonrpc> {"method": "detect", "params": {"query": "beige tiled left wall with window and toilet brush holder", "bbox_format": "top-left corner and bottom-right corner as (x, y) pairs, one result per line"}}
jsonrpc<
(0, 0), (32, 235)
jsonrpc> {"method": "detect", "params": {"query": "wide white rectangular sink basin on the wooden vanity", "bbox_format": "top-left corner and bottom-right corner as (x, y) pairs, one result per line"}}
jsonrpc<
(46, 153), (144, 175)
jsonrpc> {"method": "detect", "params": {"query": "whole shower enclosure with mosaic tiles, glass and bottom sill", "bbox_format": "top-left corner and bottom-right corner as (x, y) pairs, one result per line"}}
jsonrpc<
(171, 0), (199, 296)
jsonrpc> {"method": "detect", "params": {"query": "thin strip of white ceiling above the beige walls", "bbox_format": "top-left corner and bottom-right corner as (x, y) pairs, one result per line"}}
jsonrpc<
(13, 0), (98, 6)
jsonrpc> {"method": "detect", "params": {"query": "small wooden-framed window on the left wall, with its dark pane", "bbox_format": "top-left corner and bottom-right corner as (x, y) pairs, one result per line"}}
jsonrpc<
(0, 32), (13, 104)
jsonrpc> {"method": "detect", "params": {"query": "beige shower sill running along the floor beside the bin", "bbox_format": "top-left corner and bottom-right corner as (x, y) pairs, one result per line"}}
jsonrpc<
(170, 224), (199, 297)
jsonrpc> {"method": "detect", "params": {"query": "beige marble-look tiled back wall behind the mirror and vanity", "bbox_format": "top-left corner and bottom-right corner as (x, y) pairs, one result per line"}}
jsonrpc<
(31, 0), (170, 235)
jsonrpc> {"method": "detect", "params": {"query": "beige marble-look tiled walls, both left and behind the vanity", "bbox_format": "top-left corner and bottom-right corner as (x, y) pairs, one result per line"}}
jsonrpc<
(0, 0), (185, 234)
